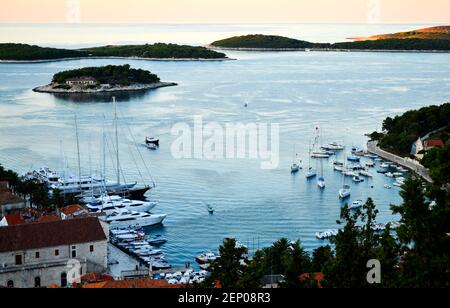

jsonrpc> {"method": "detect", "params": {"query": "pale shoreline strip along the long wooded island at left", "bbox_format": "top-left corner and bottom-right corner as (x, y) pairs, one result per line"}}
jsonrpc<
(0, 56), (232, 64)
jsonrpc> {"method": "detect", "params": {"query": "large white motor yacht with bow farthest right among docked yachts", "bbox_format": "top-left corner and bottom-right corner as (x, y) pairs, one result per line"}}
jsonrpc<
(102, 209), (167, 228)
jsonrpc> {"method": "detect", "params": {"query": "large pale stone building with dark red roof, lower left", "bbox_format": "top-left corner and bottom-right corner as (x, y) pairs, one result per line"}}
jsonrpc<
(0, 217), (108, 288)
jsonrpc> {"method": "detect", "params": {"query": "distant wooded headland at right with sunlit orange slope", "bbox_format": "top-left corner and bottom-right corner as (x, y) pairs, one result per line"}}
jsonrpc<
(207, 26), (450, 52)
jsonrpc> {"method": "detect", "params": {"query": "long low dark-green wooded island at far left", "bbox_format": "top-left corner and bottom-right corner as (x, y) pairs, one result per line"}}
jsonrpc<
(0, 43), (230, 63)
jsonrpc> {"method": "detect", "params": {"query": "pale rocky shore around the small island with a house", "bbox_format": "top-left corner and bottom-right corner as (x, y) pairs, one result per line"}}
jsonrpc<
(33, 82), (178, 94)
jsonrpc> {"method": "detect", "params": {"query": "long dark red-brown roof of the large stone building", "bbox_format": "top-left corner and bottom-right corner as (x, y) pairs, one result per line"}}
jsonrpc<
(0, 217), (106, 252)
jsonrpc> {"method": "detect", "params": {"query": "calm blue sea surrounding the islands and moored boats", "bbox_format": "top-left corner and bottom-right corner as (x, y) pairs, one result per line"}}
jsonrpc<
(0, 24), (450, 266)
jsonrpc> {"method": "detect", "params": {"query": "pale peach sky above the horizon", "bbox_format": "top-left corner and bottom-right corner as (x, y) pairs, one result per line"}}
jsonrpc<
(0, 0), (450, 23)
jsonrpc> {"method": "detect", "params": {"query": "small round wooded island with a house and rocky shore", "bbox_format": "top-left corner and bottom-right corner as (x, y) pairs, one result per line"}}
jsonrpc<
(33, 64), (177, 94)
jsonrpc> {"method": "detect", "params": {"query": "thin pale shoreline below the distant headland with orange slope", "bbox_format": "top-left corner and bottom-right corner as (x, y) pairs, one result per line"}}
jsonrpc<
(205, 45), (450, 53)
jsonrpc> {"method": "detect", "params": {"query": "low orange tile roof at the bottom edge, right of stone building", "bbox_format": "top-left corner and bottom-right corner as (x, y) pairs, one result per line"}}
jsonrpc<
(83, 279), (187, 289)
